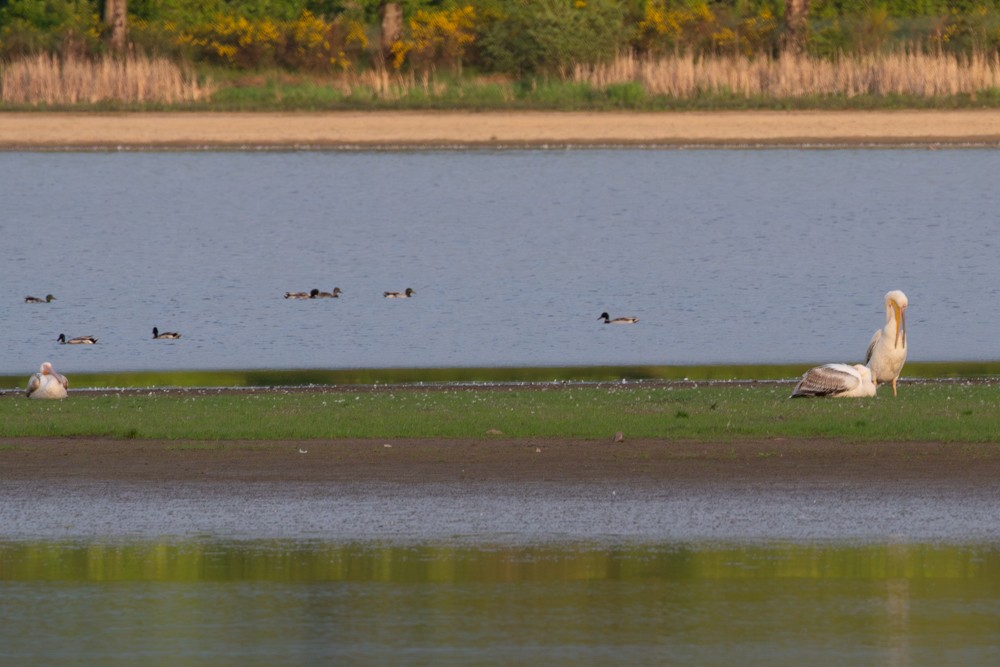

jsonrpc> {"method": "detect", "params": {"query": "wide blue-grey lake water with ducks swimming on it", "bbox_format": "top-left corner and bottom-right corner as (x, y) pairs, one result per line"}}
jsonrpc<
(0, 150), (1000, 374)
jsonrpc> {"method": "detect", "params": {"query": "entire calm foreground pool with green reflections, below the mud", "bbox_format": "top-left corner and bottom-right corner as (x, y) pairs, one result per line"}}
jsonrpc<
(0, 540), (1000, 667)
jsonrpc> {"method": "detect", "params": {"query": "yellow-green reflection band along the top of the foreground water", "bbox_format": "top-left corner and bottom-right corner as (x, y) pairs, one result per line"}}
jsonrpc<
(0, 540), (1000, 583)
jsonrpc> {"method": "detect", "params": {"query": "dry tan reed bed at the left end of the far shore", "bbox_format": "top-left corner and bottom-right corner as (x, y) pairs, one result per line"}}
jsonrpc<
(0, 53), (213, 106)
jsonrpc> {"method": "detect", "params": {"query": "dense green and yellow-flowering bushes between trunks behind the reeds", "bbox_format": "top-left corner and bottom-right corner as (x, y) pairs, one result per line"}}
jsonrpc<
(0, 0), (1000, 76)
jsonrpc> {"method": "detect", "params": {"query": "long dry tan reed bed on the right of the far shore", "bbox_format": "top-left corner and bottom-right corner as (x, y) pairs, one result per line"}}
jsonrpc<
(573, 52), (1000, 99)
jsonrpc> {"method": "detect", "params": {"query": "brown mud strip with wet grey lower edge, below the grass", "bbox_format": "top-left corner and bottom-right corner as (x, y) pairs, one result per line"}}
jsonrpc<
(7, 438), (1000, 542)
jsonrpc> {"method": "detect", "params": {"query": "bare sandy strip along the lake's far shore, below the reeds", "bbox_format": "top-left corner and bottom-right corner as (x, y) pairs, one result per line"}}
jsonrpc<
(0, 110), (1000, 150)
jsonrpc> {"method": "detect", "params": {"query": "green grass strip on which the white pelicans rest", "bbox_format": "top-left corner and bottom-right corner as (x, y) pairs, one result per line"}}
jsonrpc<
(0, 382), (1000, 443)
